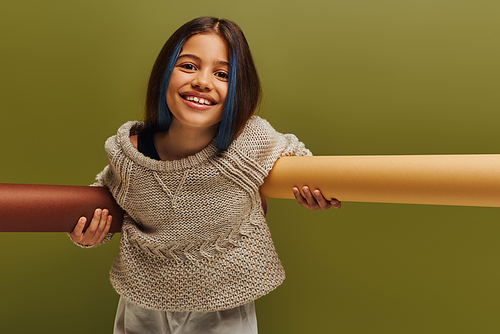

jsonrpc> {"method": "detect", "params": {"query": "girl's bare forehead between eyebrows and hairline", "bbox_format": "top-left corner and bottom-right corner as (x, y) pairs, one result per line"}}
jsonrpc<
(180, 34), (229, 62)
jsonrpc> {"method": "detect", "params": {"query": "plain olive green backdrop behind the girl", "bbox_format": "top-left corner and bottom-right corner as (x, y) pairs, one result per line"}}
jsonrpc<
(0, 0), (500, 334)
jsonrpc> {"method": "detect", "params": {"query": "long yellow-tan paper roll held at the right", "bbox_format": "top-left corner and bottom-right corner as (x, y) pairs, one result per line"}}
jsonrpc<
(261, 154), (500, 207)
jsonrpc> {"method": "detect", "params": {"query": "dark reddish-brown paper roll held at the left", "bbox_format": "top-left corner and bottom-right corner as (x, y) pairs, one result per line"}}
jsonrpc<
(0, 183), (123, 232)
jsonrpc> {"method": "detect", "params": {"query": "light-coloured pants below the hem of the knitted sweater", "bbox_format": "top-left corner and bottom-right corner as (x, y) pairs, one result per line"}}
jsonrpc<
(113, 297), (257, 334)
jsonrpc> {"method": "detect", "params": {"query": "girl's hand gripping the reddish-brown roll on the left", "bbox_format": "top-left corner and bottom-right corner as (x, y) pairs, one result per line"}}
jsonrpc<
(68, 209), (113, 246)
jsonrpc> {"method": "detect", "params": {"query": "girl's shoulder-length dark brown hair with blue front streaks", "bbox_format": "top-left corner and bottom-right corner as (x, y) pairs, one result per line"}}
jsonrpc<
(145, 16), (262, 150)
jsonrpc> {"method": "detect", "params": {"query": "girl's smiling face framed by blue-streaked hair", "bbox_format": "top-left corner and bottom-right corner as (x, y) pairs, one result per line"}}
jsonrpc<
(166, 34), (229, 134)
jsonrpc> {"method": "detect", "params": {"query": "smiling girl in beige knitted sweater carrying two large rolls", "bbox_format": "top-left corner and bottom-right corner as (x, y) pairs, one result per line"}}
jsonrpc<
(70, 17), (340, 333)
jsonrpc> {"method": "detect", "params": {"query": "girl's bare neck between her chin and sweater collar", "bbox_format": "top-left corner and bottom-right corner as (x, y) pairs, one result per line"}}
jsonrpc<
(154, 122), (217, 160)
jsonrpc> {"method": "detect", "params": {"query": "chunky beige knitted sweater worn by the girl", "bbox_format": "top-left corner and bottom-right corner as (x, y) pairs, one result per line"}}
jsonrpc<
(93, 116), (311, 312)
